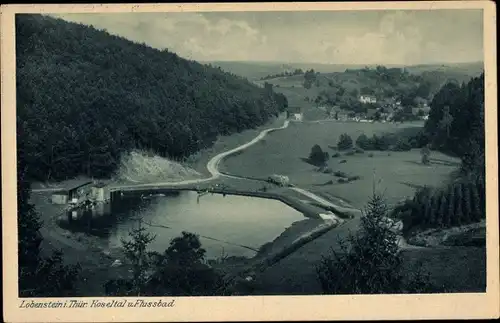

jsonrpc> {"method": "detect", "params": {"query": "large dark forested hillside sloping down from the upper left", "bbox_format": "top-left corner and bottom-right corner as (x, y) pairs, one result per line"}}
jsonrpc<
(16, 15), (287, 180)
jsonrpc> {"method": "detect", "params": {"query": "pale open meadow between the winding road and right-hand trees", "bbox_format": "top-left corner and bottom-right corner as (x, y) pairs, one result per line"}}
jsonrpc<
(221, 122), (459, 207)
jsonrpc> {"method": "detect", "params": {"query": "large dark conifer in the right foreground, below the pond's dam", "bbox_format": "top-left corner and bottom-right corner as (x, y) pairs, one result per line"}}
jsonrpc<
(316, 192), (433, 294)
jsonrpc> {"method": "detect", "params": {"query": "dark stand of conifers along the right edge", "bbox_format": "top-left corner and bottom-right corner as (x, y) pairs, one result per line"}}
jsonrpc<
(395, 74), (486, 235)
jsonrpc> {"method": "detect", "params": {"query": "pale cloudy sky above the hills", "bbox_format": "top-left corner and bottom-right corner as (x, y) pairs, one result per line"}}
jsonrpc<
(48, 9), (483, 65)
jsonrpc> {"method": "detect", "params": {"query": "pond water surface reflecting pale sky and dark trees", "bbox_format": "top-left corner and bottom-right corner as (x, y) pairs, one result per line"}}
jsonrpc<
(59, 191), (304, 258)
